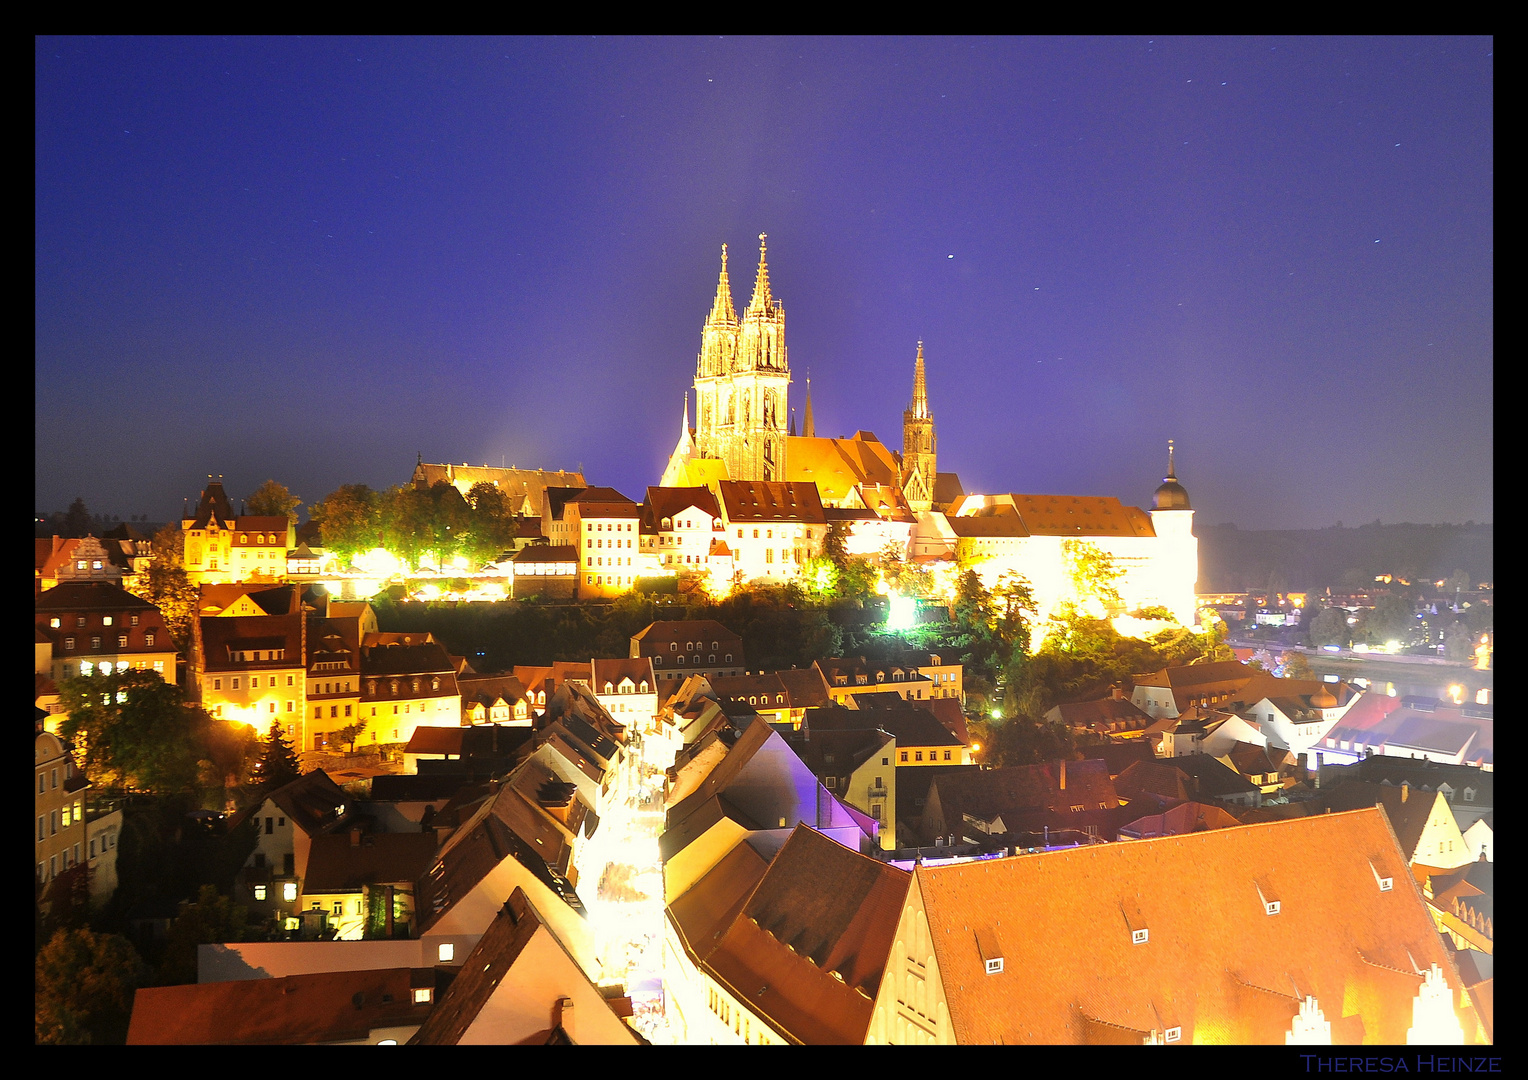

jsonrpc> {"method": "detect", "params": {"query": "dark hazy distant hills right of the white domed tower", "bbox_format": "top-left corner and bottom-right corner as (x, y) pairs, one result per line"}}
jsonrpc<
(1195, 521), (1494, 593)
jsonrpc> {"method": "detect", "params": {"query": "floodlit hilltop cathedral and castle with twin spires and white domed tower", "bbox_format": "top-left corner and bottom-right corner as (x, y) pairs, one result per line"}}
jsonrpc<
(660, 234), (1198, 625)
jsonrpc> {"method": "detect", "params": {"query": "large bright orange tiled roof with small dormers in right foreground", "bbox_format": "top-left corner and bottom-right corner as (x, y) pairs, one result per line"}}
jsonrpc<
(915, 810), (1459, 1045)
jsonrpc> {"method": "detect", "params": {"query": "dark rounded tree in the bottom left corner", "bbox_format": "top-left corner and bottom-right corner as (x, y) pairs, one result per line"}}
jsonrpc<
(32, 929), (147, 1043)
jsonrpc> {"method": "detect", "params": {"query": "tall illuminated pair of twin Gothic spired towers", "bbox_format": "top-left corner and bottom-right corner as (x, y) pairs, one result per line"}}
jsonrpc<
(695, 232), (790, 480)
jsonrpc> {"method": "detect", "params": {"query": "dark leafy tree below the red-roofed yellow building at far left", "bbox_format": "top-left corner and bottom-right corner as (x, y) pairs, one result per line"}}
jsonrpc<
(58, 669), (217, 793)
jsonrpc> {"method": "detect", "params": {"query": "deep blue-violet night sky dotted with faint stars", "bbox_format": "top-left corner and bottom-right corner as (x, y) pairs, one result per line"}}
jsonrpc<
(35, 38), (1494, 529)
